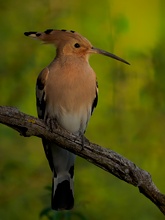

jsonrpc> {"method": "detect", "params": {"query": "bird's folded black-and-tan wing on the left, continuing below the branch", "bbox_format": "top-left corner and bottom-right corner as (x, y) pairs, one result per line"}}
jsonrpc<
(36, 67), (54, 171)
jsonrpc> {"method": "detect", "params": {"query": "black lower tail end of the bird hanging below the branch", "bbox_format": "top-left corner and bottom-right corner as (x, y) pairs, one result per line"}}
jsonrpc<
(51, 174), (74, 211)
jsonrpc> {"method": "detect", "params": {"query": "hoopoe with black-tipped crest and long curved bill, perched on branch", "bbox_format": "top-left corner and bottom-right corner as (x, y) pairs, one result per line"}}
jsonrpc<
(24, 29), (129, 211)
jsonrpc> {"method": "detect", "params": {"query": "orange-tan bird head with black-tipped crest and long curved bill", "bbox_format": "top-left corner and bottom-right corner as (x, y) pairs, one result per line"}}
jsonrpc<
(24, 29), (129, 64)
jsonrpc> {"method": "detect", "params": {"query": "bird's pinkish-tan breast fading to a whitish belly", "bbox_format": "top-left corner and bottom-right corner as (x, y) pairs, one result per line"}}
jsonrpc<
(46, 58), (96, 133)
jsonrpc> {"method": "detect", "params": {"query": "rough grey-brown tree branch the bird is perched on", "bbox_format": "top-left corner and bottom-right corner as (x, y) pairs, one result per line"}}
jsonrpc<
(0, 106), (165, 215)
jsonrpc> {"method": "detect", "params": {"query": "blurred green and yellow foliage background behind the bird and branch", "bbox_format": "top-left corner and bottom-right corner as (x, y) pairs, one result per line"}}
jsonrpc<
(0, 0), (165, 220)
